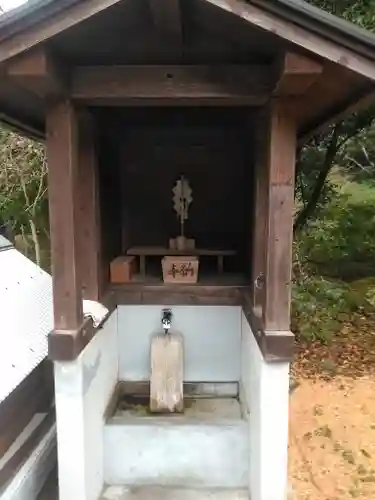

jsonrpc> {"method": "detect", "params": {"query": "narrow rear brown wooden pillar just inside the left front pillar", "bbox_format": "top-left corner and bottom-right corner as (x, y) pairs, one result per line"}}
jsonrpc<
(78, 111), (101, 300)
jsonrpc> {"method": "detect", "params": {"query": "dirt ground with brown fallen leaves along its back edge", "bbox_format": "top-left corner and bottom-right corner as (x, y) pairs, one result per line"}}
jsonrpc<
(289, 314), (375, 500)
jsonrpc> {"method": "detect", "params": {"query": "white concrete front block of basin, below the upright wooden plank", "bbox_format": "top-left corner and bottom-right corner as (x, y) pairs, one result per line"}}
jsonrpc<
(104, 400), (250, 488)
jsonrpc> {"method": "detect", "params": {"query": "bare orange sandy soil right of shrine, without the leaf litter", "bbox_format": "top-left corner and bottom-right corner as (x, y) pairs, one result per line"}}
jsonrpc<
(289, 374), (375, 500)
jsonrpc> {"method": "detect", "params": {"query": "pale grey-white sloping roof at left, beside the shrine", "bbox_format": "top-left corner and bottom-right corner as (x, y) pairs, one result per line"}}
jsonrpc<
(0, 246), (53, 405)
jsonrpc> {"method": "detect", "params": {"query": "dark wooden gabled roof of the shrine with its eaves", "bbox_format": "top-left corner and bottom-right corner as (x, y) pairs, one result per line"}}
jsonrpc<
(0, 0), (375, 137)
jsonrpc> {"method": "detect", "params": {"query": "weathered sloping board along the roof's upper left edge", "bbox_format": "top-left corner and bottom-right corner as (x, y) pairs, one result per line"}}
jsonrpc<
(0, 0), (124, 62)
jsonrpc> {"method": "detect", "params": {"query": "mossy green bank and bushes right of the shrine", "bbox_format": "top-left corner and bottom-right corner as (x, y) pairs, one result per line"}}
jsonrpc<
(292, 175), (375, 342)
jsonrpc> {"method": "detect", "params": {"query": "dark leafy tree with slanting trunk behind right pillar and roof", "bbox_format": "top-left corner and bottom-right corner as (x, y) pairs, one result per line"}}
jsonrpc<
(294, 0), (375, 231)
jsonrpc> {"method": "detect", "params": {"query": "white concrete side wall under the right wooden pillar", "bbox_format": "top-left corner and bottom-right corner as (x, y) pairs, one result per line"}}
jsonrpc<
(242, 313), (289, 500)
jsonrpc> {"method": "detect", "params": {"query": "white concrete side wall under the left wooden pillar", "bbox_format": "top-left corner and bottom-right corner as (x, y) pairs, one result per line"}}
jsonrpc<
(55, 311), (118, 500)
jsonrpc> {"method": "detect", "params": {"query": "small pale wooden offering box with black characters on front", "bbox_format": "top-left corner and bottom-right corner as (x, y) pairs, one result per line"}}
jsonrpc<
(162, 256), (199, 283)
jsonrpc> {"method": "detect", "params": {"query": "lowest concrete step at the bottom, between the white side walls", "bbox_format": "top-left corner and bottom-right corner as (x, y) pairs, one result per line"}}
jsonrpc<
(100, 486), (249, 500)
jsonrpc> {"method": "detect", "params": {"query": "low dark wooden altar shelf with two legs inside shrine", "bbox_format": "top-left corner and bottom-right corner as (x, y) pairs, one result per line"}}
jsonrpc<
(126, 246), (236, 277)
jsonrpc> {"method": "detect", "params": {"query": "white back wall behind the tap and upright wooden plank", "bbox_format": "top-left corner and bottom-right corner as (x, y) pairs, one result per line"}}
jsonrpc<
(118, 305), (241, 382)
